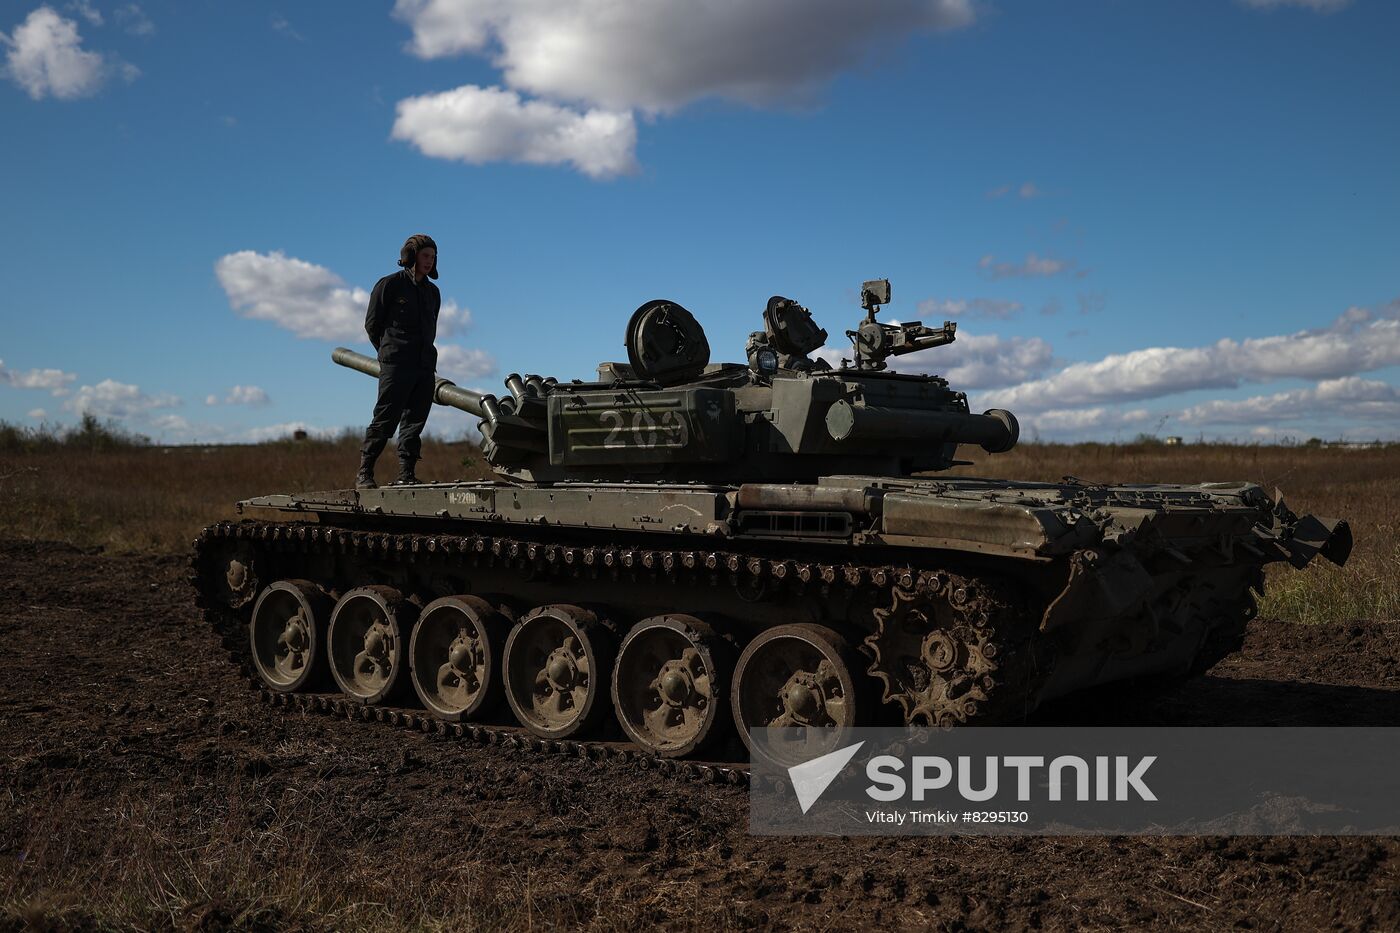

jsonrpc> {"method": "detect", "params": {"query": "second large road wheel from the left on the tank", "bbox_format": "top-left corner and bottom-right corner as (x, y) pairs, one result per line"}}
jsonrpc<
(328, 586), (417, 706)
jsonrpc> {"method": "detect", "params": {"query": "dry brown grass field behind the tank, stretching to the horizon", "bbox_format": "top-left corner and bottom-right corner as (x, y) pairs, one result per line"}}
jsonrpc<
(0, 426), (1400, 622)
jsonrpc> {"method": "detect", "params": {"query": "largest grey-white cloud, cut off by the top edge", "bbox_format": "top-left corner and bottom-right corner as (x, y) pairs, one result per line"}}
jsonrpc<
(395, 0), (974, 112)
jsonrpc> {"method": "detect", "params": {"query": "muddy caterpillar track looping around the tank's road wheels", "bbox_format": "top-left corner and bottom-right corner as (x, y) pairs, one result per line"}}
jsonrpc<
(190, 521), (1052, 785)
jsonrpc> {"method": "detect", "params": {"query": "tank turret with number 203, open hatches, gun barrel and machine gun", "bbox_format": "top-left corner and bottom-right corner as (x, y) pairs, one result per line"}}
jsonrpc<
(332, 279), (1019, 483)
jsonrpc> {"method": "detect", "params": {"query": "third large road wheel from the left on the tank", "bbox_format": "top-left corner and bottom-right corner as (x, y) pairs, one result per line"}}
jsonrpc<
(409, 595), (511, 723)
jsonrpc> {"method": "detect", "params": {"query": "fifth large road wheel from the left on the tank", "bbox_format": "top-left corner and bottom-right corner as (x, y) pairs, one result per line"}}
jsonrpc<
(612, 615), (734, 758)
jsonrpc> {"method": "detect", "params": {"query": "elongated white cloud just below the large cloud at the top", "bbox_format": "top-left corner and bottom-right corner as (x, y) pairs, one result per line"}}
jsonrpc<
(392, 84), (637, 178)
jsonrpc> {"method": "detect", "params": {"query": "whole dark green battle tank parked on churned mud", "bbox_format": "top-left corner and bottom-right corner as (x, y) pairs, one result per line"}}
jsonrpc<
(193, 280), (1351, 775)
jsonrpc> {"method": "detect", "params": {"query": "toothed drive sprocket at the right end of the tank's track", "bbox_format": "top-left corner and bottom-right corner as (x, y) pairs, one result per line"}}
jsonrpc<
(865, 572), (1046, 727)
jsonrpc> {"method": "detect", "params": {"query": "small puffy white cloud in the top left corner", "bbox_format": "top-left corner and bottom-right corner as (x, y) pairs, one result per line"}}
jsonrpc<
(0, 7), (140, 101)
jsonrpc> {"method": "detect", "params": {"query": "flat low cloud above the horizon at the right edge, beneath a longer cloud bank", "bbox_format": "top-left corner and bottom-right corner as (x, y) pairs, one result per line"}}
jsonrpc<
(1180, 375), (1400, 424)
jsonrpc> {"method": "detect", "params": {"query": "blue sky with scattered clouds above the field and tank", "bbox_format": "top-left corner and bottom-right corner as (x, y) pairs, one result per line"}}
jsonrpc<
(0, 0), (1400, 443)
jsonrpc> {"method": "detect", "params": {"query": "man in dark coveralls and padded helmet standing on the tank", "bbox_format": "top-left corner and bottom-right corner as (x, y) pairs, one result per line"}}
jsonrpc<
(354, 234), (442, 489)
